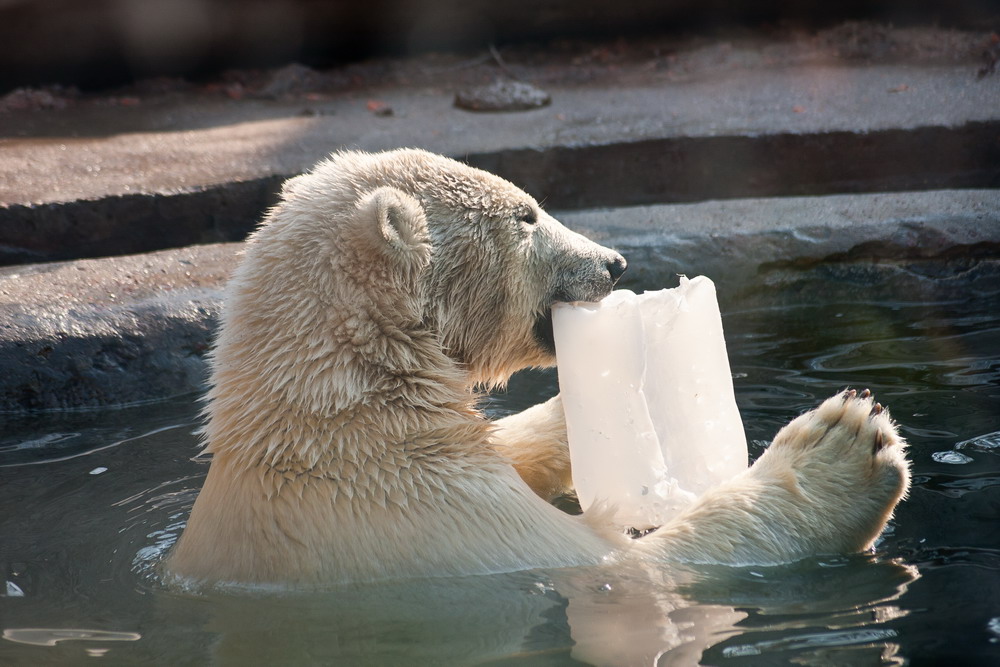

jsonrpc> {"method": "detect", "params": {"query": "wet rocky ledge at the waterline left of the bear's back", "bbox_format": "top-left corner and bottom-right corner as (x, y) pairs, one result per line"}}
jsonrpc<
(0, 244), (240, 412)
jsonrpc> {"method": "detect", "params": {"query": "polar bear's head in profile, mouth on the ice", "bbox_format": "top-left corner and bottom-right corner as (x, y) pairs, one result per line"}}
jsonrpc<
(229, 150), (625, 394)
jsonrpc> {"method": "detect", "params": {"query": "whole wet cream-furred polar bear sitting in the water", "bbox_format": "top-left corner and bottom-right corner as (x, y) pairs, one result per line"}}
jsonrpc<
(167, 150), (909, 586)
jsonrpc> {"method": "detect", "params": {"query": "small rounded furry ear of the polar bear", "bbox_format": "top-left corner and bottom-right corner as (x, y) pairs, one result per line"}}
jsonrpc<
(353, 187), (431, 268)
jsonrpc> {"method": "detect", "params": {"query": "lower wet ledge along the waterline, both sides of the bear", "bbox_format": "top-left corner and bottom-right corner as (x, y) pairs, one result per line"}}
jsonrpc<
(0, 190), (1000, 419)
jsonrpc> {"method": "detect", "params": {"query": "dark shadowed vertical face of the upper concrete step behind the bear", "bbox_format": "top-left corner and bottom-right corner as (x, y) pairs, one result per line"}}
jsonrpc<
(0, 121), (1000, 265)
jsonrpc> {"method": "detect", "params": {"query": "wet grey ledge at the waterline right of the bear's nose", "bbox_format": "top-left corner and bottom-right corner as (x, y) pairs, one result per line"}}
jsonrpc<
(560, 190), (1000, 298)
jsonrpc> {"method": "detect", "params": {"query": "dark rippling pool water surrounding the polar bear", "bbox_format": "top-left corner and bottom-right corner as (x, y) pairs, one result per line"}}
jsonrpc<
(0, 260), (1000, 665)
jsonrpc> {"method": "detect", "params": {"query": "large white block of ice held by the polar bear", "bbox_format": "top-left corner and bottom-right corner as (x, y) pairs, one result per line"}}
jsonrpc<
(552, 276), (747, 528)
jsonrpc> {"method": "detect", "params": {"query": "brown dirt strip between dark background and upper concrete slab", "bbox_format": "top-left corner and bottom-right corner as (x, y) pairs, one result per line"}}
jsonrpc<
(0, 22), (1000, 137)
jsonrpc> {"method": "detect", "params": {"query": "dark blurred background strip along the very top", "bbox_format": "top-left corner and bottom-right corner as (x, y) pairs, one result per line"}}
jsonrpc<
(0, 0), (1000, 92)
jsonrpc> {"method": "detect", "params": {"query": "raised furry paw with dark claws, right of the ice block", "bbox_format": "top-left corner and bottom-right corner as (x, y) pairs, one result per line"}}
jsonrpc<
(754, 389), (910, 553)
